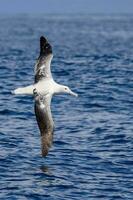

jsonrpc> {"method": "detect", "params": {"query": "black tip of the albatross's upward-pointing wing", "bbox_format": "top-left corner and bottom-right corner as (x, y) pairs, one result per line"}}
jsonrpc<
(40, 36), (52, 56)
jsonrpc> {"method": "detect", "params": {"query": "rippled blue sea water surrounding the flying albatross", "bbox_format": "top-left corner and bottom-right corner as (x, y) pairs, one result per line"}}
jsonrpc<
(0, 15), (133, 200)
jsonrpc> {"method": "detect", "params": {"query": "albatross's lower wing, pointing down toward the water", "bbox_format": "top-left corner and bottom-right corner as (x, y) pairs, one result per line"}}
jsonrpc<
(33, 89), (54, 157)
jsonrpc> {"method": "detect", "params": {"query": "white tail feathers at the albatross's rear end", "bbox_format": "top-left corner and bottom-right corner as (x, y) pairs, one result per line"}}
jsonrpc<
(11, 85), (34, 95)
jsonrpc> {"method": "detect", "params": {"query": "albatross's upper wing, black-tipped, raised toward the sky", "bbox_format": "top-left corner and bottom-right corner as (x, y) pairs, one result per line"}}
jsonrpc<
(35, 36), (53, 83)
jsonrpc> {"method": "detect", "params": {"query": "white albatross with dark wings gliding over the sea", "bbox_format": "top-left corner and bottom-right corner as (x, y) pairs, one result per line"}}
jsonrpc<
(12, 36), (78, 157)
